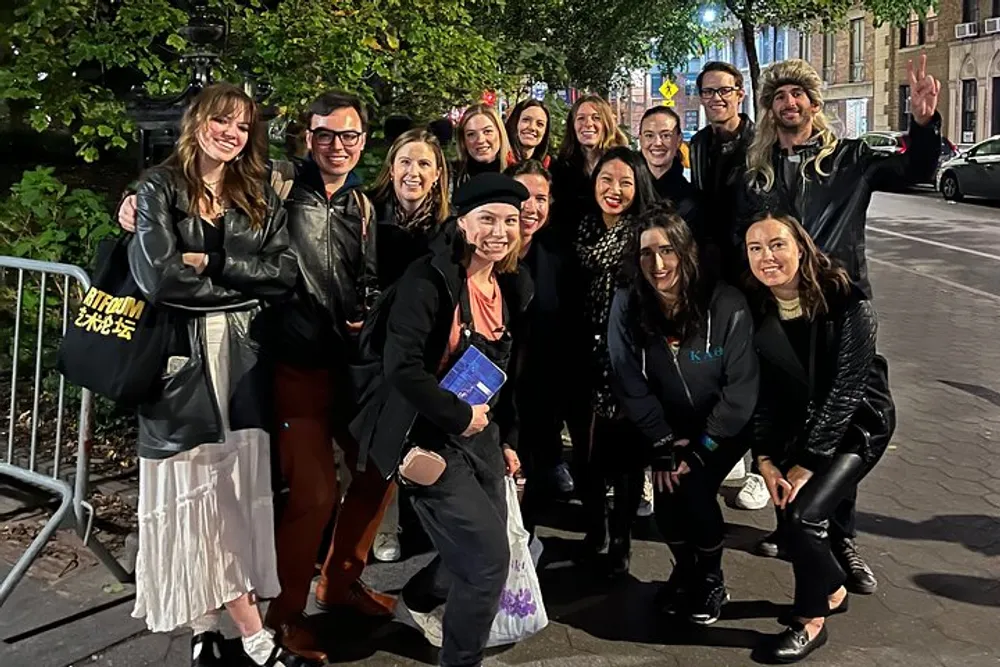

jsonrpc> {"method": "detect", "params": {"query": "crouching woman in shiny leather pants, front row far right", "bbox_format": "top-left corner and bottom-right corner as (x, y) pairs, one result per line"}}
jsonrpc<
(746, 213), (895, 663)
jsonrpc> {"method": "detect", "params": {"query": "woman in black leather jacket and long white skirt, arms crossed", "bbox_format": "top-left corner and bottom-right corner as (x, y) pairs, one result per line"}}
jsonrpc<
(129, 83), (296, 667)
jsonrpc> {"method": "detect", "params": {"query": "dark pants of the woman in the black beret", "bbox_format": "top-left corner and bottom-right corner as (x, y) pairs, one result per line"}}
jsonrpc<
(403, 436), (510, 667)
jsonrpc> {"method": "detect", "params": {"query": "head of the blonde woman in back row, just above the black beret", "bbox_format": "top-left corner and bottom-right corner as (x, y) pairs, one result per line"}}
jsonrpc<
(454, 104), (510, 190)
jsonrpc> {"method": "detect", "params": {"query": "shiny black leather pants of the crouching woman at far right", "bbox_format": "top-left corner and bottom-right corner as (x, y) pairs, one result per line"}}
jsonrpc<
(783, 454), (867, 618)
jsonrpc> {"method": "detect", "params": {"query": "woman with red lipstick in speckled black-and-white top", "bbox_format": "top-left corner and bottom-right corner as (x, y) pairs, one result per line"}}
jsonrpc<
(574, 147), (655, 576)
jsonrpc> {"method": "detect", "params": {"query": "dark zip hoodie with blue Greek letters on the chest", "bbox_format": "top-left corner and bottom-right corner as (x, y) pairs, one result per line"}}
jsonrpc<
(608, 283), (758, 468)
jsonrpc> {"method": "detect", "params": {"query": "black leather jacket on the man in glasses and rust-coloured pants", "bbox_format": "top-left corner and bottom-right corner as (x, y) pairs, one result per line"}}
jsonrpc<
(278, 160), (378, 368)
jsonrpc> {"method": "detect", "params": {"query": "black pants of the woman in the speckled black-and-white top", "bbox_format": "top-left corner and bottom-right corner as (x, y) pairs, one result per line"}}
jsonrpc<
(573, 416), (646, 553)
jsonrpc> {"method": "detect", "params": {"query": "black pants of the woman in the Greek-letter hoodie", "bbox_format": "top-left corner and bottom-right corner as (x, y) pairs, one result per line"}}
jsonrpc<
(653, 439), (750, 551)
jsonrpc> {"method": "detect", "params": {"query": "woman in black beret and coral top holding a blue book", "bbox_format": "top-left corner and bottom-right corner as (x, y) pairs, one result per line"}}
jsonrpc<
(368, 174), (531, 666)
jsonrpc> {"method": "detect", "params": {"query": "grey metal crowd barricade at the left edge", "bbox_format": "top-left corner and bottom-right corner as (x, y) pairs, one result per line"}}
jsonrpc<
(0, 256), (132, 607)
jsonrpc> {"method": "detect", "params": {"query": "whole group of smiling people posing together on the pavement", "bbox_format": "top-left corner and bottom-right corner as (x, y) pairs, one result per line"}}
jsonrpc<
(119, 51), (940, 667)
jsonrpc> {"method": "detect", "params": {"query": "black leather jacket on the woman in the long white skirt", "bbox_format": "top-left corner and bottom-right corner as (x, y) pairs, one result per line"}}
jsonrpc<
(129, 167), (296, 458)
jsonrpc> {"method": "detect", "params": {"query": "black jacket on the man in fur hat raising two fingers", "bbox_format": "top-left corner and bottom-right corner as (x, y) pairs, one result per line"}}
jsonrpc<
(734, 115), (941, 297)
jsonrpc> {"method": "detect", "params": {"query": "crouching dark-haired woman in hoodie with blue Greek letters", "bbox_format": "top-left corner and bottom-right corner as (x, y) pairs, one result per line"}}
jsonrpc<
(608, 204), (758, 625)
